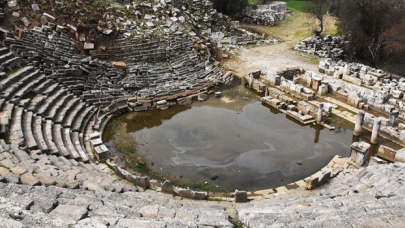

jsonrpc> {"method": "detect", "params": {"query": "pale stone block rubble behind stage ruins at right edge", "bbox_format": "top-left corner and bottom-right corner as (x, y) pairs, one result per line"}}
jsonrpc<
(318, 59), (405, 116)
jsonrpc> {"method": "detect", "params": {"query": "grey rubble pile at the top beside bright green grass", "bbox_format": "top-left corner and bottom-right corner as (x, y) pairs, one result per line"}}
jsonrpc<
(235, 2), (287, 26)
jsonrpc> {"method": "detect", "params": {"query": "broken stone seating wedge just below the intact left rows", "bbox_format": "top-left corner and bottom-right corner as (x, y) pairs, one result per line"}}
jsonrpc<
(0, 140), (136, 192)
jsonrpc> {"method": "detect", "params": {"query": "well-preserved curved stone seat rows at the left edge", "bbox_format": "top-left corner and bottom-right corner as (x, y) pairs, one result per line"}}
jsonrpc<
(0, 48), (98, 162)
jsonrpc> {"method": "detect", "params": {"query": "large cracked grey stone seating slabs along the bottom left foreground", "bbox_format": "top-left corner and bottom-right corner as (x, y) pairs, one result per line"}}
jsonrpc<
(0, 183), (234, 228)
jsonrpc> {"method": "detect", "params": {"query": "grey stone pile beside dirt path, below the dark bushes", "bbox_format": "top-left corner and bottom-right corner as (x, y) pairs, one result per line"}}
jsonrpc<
(293, 35), (346, 61)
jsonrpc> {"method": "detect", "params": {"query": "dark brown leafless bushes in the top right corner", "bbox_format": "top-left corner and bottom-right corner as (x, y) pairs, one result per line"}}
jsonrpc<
(330, 0), (405, 73)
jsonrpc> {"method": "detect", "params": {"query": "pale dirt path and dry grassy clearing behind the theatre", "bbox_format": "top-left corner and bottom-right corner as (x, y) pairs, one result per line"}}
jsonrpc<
(223, 11), (336, 76)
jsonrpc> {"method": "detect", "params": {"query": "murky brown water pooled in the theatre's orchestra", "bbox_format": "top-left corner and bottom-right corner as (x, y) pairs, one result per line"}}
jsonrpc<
(105, 98), (398, 191)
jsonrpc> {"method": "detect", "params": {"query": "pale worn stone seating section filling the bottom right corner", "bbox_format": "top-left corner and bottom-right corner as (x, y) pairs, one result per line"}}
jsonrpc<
(236, 163), (405, 228)
